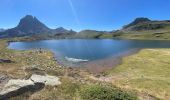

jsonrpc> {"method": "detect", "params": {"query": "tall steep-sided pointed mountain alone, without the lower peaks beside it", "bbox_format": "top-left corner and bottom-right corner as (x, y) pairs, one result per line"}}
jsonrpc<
(0, 15), (50, 37)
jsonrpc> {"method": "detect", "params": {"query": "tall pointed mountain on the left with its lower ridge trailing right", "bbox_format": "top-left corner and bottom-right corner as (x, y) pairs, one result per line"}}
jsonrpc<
(0, 15), (75, 38)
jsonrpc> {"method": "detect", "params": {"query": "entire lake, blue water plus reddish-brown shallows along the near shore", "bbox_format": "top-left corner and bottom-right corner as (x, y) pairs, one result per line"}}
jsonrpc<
(8, 39), (170, 74)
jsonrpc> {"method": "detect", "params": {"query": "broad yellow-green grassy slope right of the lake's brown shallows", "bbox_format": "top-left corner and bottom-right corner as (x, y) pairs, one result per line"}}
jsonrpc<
(110, 49), (170, 100)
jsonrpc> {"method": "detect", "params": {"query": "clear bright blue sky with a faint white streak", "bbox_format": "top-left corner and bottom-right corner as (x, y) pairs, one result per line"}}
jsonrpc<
(0, 0), (170, 31)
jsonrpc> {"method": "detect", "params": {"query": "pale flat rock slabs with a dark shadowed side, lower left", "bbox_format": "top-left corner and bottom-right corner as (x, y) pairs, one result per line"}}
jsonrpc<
(0, 74), (61, 100)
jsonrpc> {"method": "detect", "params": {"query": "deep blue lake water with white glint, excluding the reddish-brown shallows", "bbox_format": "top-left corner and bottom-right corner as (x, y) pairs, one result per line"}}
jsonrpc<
(8, 39), (170, 66)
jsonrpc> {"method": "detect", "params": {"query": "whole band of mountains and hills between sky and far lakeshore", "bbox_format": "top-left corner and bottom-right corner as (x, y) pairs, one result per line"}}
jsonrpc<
(0, 15), (170, 39)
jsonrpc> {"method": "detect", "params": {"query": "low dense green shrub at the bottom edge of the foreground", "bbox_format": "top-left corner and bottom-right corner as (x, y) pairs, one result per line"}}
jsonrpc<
(80, 85), (137, 100)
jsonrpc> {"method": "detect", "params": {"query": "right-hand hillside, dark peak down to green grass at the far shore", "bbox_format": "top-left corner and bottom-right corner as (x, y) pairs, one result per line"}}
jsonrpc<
(113, 18), (170, 40)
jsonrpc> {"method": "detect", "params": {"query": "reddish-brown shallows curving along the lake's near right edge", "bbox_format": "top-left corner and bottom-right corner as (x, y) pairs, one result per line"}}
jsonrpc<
(80, 49), (140, 74)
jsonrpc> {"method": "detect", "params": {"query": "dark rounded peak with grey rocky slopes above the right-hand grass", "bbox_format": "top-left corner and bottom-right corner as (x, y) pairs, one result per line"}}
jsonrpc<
(122, 17), (170, 31)
